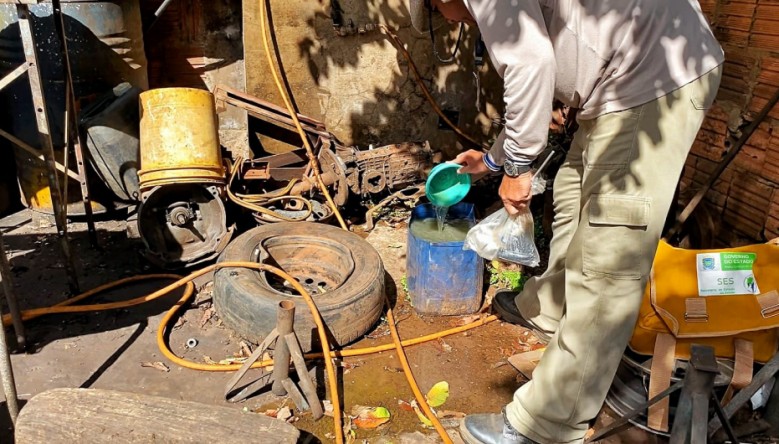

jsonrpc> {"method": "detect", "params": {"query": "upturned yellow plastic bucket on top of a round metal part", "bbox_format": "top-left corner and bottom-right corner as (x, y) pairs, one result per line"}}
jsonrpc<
(138, 88), (225, 189)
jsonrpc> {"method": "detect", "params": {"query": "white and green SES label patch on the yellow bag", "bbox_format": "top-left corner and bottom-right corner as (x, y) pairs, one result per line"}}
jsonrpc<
(696, 253), (760, 296)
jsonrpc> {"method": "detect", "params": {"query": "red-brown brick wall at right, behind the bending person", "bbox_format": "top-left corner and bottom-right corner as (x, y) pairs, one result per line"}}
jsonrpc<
(682, 0), (779, 245)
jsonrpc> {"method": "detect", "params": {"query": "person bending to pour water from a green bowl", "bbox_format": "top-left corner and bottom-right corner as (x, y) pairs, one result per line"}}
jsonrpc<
(409, 0), (724, 444)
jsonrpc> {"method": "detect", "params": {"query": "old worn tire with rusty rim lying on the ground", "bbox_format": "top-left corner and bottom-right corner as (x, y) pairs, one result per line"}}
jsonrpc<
(213, 222), (384, 351)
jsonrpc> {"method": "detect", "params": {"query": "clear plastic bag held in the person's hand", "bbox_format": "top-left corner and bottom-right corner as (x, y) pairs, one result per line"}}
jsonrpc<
(463, 208), (540, 267)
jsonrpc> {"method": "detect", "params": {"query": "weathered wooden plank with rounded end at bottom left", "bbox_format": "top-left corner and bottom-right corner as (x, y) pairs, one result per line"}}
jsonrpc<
(16, 388), (300, 444)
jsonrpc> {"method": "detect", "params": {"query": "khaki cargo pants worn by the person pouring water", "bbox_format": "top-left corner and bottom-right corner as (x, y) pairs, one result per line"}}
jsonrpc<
(506, 68), (721, 443)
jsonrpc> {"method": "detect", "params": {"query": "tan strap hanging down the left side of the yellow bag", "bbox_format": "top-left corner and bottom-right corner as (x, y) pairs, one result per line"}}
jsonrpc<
(646, 333), (676, 432)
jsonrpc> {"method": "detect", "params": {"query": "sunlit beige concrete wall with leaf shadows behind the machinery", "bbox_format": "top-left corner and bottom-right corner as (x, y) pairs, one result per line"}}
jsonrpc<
(243, 0), (502, 156)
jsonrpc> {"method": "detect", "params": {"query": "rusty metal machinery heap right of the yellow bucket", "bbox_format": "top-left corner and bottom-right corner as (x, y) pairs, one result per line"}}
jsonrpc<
(214, 86), (435, 223)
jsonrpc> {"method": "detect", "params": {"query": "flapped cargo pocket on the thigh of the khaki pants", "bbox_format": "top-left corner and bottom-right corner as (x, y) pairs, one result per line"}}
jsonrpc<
(582, 194), (654, 279)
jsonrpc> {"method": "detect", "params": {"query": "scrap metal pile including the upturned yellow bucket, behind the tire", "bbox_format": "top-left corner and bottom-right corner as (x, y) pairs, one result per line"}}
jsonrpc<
(115, 86), (436, 268)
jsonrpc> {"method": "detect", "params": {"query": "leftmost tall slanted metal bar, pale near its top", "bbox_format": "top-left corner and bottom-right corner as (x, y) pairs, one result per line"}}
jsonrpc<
(16, 5), (79, 294)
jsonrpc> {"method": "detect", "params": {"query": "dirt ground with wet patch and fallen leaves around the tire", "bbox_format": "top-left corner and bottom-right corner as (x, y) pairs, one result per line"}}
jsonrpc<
(0, 211), (657, 443)
